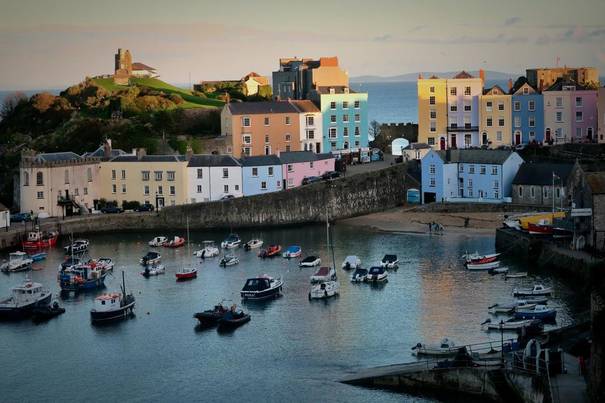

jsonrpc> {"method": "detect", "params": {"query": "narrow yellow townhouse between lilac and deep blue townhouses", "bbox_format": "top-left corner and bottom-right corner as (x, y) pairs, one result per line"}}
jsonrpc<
(479, 85), (512, 148)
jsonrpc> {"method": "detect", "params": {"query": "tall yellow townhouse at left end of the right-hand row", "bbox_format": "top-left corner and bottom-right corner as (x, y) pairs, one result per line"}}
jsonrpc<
(418, 76), (447, 147)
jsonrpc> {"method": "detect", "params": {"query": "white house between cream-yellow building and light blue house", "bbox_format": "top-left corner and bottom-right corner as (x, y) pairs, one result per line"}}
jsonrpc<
(187, 154), (243, 203)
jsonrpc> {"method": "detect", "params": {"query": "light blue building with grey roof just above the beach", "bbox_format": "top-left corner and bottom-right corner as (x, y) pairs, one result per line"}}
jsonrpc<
(421, 149), (523, 203)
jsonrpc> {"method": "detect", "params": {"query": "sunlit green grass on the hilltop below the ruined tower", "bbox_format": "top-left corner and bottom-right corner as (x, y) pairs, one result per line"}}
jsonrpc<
(92, 77), (225, 109)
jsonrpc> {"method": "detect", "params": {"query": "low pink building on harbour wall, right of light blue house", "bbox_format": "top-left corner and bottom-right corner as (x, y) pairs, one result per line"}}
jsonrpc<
(279, 151), (335, 189)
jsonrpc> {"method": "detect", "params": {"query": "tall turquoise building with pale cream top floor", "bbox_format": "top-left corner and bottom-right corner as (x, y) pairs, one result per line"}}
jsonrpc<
(314, 87), (368, 153)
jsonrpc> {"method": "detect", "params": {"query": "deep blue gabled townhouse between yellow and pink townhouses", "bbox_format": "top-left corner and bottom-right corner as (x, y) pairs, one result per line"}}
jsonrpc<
(511, 83), (544, 145)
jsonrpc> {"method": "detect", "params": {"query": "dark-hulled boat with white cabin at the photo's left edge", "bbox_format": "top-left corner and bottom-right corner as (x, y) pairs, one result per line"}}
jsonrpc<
(0, 278), (52, 319)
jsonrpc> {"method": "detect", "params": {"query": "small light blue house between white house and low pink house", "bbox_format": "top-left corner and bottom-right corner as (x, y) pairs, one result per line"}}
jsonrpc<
(241, 155), (283, 196)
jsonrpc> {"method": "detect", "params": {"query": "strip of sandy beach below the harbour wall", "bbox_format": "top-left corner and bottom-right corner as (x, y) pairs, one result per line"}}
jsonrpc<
(340, 207), (502, 235)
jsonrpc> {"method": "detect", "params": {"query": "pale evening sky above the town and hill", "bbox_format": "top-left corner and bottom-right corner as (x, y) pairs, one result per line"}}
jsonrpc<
(0, 0), (605, 90)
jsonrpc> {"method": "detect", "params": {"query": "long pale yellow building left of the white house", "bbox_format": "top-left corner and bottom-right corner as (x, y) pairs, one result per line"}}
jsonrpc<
(99, 149), (187, 208)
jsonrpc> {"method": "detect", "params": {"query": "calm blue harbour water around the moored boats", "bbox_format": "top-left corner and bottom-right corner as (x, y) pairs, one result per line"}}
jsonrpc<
(0, 225), (583, 402)
